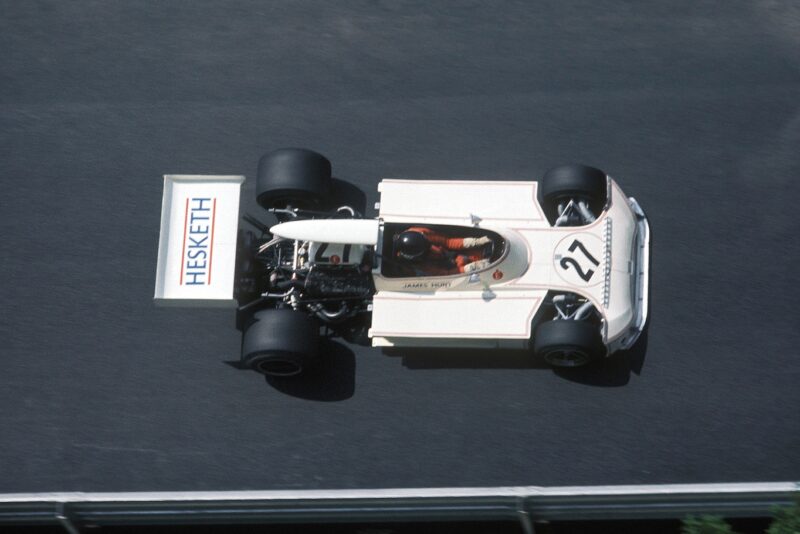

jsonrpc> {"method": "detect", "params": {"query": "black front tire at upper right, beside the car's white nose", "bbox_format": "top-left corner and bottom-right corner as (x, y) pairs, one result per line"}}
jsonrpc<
(541, 165), (608, 222)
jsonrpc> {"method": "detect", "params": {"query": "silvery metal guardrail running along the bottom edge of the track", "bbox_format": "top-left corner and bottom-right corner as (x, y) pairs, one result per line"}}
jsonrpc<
(0, 482), (800, 533)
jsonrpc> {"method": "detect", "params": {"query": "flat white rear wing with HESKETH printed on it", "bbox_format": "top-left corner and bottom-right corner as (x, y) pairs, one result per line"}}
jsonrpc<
(154, 174), (245, 307)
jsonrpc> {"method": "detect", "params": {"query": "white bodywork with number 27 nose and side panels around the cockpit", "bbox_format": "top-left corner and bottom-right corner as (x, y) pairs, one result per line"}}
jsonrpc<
(370, 179), (647, 352)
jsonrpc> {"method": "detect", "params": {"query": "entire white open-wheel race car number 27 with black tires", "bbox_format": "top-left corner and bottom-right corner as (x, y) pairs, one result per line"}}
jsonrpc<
(155, 149), (649, 376)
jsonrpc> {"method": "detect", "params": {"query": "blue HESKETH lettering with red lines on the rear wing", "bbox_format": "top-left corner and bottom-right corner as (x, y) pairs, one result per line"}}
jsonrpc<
(183, 198), (214, 286)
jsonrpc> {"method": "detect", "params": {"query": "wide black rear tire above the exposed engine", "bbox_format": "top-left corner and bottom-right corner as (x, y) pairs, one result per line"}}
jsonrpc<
(256, 148), (331, 213)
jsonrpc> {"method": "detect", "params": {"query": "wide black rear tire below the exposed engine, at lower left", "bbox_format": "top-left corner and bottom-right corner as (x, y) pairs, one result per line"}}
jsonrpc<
(242, 309), (320, 377)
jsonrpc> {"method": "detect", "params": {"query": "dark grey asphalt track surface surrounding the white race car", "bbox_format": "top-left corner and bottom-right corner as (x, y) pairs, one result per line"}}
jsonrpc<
(0, 0), (800, 492)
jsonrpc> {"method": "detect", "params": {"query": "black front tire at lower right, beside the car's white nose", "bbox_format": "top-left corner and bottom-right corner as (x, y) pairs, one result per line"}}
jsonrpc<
(533, 319), (606, 367)
